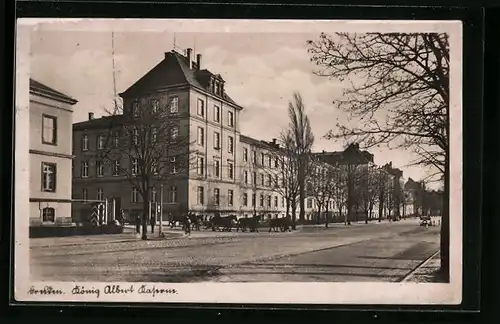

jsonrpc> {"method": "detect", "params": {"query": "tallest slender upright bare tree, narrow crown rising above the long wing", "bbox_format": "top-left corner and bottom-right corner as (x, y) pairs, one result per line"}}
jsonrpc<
(288, 92), (314, 224)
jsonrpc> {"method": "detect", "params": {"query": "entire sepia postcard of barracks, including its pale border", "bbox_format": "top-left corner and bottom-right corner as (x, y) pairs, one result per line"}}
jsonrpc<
(13, 19), (462, 304)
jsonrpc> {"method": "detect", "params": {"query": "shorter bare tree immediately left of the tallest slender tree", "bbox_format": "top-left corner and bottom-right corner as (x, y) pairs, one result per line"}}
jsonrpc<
(266, 129), (300, 230)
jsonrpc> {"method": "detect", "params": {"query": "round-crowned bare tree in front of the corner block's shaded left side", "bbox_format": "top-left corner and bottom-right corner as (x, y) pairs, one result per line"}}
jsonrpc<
(96, 98), (192, 239)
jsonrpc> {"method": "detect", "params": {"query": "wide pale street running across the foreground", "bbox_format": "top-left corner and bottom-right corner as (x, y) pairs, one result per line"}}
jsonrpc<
(30, 219), (439, 282)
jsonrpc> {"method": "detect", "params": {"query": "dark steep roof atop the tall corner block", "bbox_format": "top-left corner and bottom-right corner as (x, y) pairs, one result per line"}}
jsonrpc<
(120, 51), (240, 107)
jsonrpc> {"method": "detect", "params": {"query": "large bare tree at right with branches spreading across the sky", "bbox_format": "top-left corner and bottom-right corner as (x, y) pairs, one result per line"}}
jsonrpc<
(308, 33), (450, 280)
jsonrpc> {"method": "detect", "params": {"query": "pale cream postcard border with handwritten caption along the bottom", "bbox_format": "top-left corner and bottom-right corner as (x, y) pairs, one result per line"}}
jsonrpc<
(14, 18), (462, 305)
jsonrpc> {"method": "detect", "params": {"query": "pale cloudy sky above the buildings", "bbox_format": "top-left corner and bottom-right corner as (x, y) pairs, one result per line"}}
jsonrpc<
(25, 21), (444, 187)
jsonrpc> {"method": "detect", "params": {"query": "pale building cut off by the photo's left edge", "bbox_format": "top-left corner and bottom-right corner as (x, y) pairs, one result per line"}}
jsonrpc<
(29, 79), (77, 226)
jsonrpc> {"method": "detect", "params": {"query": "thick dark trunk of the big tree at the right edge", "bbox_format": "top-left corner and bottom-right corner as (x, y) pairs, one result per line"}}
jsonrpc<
(440, 154), (450, 282)
